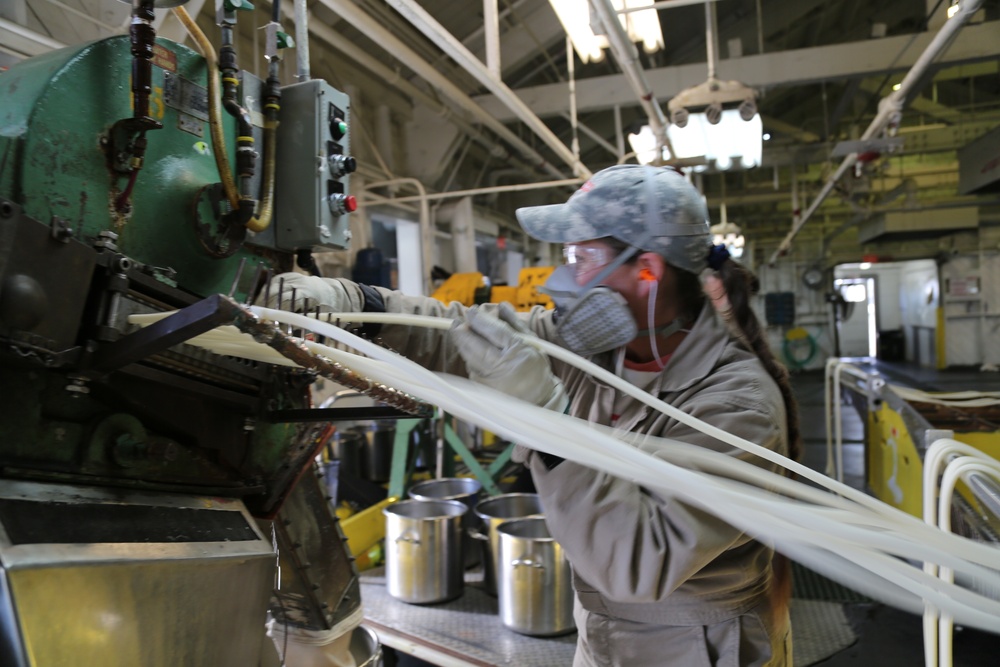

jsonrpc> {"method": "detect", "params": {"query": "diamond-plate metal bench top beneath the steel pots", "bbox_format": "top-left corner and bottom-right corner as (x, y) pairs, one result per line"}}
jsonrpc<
(361, 568), (576, 667)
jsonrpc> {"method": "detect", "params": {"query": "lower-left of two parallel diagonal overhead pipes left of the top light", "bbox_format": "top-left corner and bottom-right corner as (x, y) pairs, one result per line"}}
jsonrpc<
(314, 0), (566, 179)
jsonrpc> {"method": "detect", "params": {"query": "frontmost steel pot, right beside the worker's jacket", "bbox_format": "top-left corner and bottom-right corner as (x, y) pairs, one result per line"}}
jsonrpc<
(497, 517), (575, 637)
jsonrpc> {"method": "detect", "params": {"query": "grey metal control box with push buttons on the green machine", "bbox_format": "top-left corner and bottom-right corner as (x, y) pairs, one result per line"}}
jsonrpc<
(274, 79), (357, 250)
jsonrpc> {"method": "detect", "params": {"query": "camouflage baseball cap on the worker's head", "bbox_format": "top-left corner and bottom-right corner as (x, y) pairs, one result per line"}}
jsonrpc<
(515, 164), (712, 273)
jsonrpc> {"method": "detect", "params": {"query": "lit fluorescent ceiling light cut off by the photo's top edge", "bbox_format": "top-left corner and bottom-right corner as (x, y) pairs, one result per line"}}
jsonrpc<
(549, 0), (663, 63)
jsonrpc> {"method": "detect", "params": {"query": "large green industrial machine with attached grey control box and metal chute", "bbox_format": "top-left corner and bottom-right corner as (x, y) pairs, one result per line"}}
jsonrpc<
(0, 0), (402, 667)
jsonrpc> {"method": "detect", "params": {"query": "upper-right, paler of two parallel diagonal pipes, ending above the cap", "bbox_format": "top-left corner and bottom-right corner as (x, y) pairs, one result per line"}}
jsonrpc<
(378, 0), (591, 178)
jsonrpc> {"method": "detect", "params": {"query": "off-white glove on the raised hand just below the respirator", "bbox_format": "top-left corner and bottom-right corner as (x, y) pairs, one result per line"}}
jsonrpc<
(451, 303), (567, 412)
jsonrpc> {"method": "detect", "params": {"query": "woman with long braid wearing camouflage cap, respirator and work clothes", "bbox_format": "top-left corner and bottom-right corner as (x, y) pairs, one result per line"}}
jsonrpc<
(272, 165), (798, 667)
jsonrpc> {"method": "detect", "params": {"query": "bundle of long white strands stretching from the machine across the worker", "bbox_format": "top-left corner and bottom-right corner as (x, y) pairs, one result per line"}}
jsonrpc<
(129, 308), (1000, 632)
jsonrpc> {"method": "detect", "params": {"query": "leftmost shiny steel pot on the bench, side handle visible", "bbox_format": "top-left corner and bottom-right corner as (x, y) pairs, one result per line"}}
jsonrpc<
(382, 500), (468, 604)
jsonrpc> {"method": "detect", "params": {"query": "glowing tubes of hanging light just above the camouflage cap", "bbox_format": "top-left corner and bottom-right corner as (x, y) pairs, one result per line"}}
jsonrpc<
(667, 109), (763, 171)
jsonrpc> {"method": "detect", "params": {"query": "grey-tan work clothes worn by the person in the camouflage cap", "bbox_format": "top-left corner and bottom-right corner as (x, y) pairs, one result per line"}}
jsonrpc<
(345, 281), (791, 667)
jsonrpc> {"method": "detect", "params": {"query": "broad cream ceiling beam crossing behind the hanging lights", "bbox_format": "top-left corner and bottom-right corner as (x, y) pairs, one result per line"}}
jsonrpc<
(473, 21), (1000, 122)
